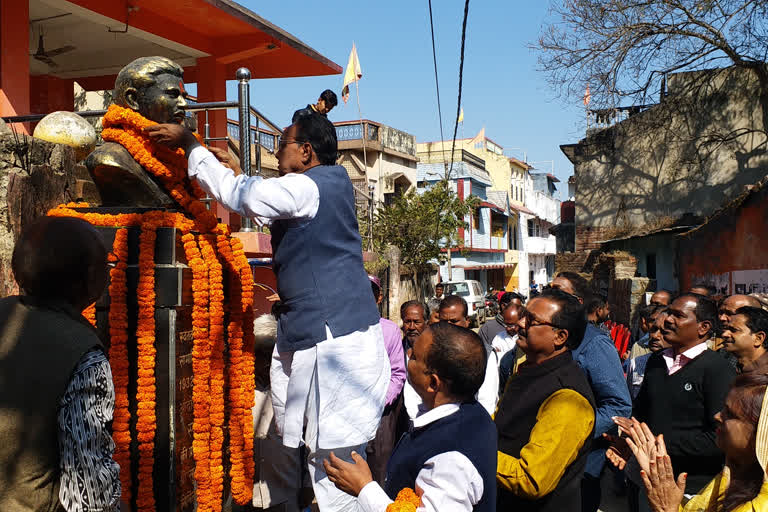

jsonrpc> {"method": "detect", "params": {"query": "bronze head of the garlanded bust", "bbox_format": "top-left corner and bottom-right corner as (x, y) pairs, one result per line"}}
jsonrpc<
(112, 57), (187, 123)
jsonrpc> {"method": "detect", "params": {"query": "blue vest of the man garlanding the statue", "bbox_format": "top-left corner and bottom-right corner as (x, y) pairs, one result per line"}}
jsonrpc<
(271, 165), (379, 351)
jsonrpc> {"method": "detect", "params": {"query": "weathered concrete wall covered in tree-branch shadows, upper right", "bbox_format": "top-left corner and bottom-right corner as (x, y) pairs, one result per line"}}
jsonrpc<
(566, 69), (768, 244)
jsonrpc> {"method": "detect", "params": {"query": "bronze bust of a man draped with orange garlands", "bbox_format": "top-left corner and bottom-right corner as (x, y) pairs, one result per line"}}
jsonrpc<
(85, 57), (187, 207)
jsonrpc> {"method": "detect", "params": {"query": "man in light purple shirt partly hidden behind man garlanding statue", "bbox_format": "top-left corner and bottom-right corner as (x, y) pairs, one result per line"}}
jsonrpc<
(365, 275), (406, 485)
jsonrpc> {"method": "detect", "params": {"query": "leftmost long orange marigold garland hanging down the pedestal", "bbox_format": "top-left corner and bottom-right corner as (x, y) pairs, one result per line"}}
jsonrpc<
(109, 228), (131, 502)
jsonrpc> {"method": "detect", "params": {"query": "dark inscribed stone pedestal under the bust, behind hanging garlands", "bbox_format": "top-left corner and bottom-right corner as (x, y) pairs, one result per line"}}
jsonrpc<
(88, 208), (196, 512)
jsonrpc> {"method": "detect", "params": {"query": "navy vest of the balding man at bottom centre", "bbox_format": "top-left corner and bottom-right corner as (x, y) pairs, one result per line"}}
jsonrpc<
(384, 400), (497, 512)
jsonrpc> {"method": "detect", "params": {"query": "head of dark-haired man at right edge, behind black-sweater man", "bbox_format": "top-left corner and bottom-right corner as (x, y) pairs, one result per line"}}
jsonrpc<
(723, 306), (768, 373)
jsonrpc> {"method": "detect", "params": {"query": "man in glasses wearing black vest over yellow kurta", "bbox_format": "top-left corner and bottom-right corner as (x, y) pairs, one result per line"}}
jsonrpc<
(495, 290), (595, 512)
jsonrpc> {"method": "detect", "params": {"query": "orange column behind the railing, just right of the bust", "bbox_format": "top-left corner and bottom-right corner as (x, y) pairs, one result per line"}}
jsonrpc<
(197, 57), (240, 228)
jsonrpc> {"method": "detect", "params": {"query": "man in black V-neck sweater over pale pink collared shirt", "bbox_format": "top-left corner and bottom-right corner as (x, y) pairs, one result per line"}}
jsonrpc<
(620, 294), (736, 510)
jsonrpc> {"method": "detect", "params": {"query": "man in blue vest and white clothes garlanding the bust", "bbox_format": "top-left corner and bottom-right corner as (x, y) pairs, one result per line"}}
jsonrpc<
(145, 114), (390, 512)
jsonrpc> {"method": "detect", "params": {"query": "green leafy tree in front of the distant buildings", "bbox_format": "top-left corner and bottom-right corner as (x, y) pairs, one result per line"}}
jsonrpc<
(360, 180), (479, 267)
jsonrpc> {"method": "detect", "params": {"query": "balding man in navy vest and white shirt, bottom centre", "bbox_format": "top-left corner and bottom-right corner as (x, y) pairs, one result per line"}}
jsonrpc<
(325, 322), (497, 512)
